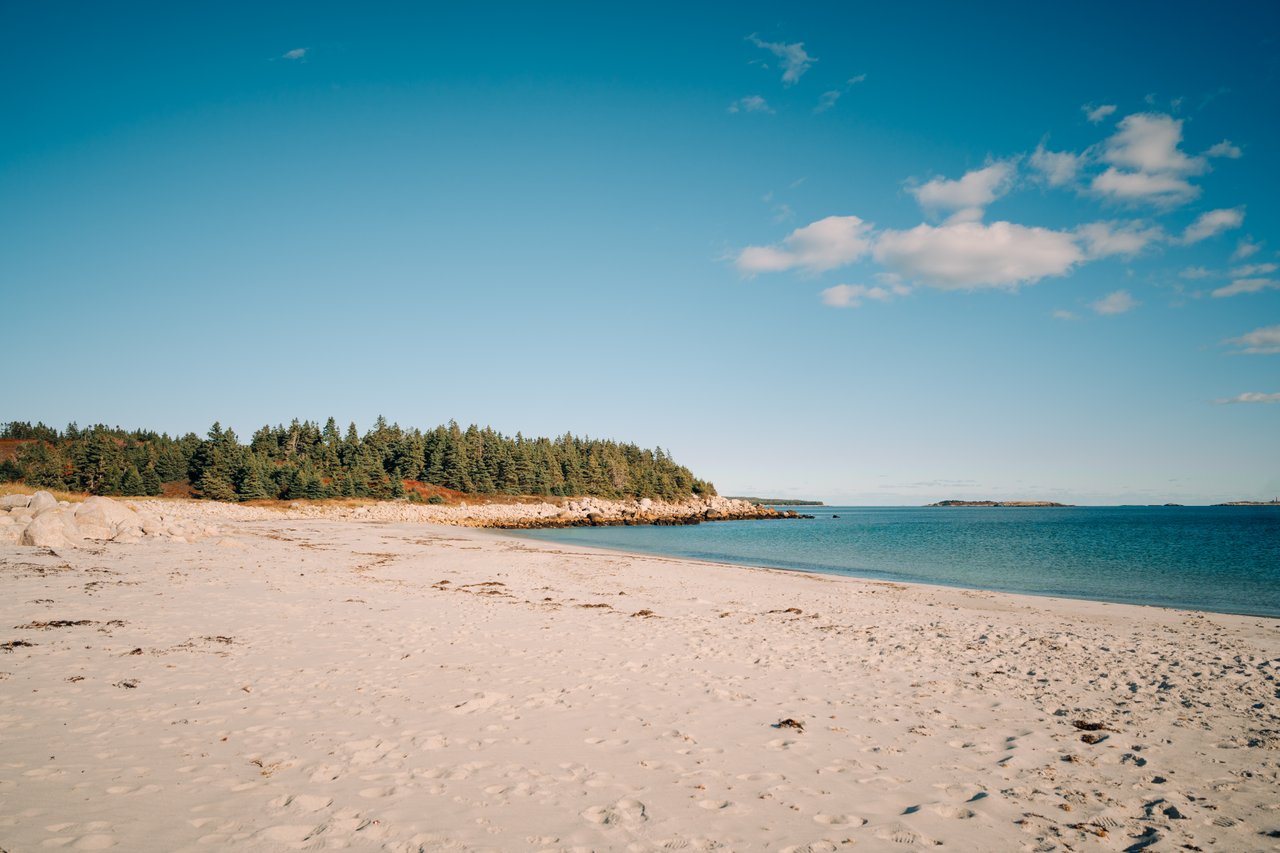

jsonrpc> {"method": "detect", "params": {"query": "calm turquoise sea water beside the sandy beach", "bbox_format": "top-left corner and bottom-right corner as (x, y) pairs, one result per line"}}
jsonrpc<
(521, 507), (1280, 616)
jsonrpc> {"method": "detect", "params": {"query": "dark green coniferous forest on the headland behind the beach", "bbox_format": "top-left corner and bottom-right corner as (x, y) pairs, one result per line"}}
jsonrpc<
(0, 418), (716, 502)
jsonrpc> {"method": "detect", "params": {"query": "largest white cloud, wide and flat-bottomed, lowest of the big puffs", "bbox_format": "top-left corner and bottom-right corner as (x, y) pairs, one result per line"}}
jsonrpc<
(873, 222), (1084, 289)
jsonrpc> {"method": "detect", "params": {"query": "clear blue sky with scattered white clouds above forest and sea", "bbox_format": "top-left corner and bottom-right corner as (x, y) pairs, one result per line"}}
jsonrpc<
(0, 3), (1280, 505)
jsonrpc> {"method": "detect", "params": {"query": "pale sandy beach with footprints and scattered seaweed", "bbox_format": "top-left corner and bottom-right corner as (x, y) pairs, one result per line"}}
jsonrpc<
(0, 507), (1280, 853)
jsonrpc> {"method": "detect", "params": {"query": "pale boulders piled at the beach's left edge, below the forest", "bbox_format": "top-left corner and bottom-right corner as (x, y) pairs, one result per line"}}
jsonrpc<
(0, 492), (225, 548)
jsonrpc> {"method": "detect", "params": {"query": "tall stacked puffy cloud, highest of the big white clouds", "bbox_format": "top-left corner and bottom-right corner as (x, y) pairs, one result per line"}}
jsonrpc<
(1093, 113), (1208, 205)
